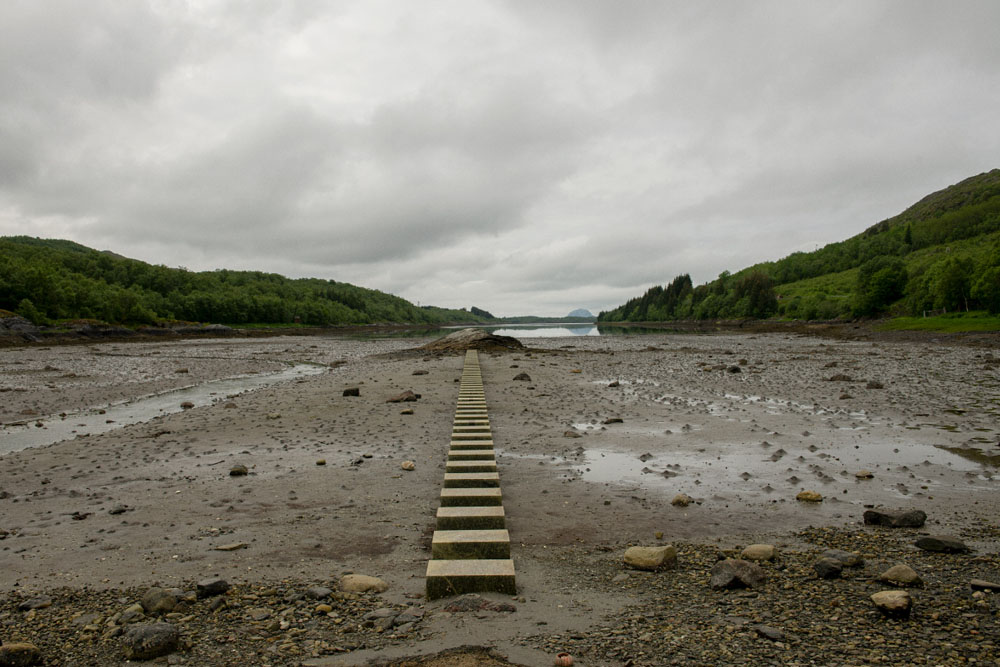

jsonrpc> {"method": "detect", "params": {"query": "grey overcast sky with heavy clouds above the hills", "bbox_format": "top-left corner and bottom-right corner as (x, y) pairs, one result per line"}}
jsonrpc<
(0, 0), (1000, 315)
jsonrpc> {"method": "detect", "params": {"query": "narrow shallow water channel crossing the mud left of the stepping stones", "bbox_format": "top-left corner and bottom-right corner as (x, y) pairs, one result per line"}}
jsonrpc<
(0, 364), (328, 455)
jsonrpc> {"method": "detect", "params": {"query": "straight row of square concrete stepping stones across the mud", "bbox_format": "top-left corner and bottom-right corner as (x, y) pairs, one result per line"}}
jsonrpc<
(427, 350), (517, 600)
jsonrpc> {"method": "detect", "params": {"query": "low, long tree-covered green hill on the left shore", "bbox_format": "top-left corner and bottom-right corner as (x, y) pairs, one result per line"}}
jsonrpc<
(0, 236), (488, 326)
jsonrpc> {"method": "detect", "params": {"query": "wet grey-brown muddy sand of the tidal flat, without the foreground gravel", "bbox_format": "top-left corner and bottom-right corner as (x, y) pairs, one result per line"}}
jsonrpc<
(0, 334), (1000, 665)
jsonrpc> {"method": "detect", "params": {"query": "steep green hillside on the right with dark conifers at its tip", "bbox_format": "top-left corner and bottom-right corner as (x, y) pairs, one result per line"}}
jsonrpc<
(598, 169), (1000, 322)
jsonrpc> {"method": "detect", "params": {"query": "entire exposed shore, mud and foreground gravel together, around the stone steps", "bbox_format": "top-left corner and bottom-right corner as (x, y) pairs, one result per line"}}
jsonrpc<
(0, 333), (1000, 666)
